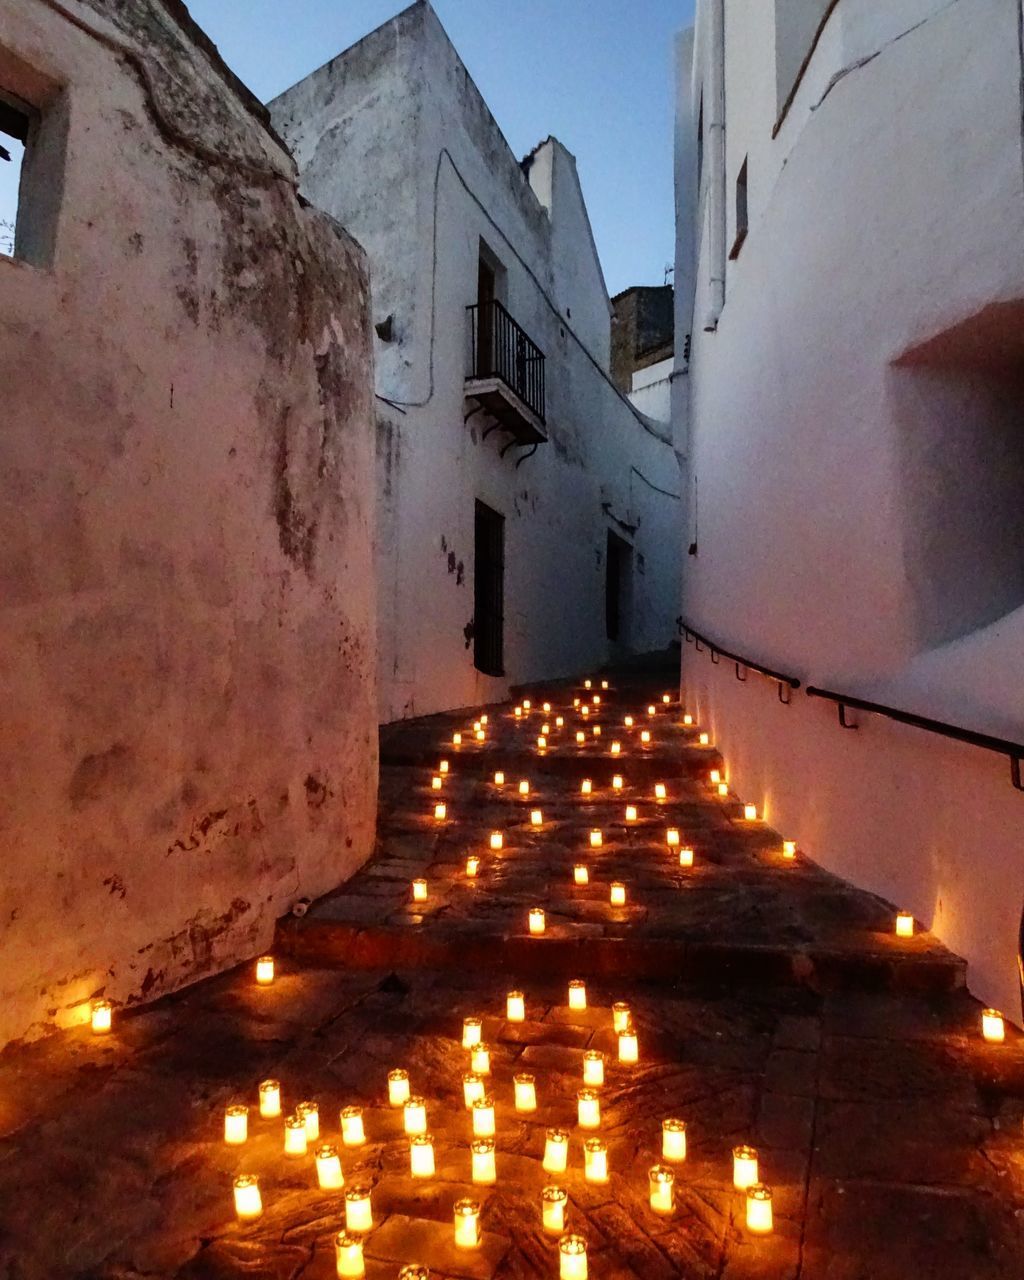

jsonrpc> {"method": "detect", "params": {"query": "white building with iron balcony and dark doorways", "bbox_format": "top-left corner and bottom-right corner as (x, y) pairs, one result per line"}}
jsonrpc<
(270, 3), (681, 721)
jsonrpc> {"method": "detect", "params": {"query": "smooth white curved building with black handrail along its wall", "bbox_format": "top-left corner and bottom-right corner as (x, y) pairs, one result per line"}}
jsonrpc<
(675, 0), (1024, 1012)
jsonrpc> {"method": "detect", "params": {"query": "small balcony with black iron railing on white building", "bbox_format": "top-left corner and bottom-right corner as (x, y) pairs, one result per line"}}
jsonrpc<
(466, 301), (548, 444)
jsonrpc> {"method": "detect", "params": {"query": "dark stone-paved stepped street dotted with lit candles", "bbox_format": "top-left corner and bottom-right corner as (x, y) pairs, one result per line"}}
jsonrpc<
(0, 686), (1024, 1280)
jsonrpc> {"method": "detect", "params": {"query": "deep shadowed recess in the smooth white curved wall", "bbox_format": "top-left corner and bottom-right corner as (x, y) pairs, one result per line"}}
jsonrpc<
(888, 303), (1024, 649)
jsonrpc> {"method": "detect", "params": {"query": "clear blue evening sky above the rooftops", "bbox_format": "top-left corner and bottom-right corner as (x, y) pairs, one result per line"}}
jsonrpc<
(0, 0), (694, 293)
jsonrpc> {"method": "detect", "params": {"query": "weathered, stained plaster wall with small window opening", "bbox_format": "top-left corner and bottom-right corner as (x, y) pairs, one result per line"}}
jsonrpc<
(0, 0), (376, 1041)
